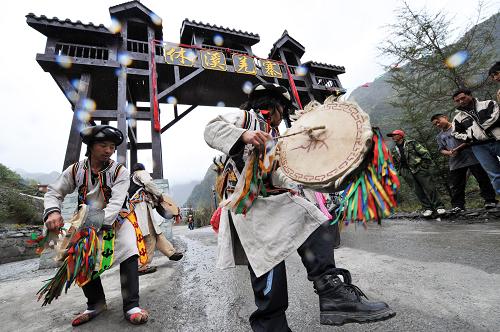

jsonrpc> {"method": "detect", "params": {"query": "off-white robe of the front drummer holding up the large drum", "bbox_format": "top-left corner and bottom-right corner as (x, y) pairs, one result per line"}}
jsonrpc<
(205, 111), (327, 277)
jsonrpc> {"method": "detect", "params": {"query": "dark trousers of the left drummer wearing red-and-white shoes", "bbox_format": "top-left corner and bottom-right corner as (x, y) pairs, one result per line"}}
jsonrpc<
(82, 255), (139, 313)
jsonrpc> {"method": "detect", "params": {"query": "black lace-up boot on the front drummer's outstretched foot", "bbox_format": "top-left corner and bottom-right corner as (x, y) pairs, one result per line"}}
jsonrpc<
(314, 269), (396, 325)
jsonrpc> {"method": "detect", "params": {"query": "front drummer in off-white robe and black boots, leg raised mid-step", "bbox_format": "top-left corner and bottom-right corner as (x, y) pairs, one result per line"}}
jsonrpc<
(205, 83), (395, 331)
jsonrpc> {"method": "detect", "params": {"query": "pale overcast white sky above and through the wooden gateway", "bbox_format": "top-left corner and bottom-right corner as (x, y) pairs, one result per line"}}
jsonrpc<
(0, 0), (500, 184)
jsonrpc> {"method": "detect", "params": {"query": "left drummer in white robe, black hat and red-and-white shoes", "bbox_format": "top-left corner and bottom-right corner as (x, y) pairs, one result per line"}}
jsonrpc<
(44, 125), (148, 326)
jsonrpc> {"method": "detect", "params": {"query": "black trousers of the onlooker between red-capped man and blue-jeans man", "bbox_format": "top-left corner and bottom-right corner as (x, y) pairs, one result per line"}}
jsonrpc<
(449, 164), (496, 209)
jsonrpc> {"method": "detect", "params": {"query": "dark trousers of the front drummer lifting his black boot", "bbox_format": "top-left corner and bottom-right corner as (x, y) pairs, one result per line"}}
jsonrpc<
(248, 222), (335, 332)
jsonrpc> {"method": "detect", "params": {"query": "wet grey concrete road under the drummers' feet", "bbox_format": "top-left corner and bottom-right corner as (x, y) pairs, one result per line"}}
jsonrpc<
(0, 219), (500, 332)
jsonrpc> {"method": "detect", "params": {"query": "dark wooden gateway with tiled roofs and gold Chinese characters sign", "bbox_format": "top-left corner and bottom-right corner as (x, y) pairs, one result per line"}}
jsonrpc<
(26, 1), (345, 179)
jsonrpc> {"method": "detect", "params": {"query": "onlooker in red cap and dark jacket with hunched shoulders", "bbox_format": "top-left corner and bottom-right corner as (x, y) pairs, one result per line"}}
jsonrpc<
(387, 129), (446, 217)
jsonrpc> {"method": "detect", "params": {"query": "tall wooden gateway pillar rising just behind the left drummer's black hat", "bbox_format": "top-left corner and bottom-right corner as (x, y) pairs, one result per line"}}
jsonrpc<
(116, 21), (128, 167)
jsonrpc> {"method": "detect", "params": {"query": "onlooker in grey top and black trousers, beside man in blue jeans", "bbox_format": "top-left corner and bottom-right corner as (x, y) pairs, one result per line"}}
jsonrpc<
(431, 114), (497, 212)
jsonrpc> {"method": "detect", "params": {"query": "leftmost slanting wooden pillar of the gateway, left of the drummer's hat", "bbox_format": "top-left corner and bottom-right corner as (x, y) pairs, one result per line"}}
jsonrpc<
(63, 73), (90, 171)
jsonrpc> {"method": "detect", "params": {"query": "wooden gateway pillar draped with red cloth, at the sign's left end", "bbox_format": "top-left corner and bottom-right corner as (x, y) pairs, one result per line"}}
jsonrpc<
(148, 26), (163, 179)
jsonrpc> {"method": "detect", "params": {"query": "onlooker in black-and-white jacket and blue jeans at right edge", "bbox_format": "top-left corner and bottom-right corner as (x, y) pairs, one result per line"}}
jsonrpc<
(452, 89), (500, 194)
